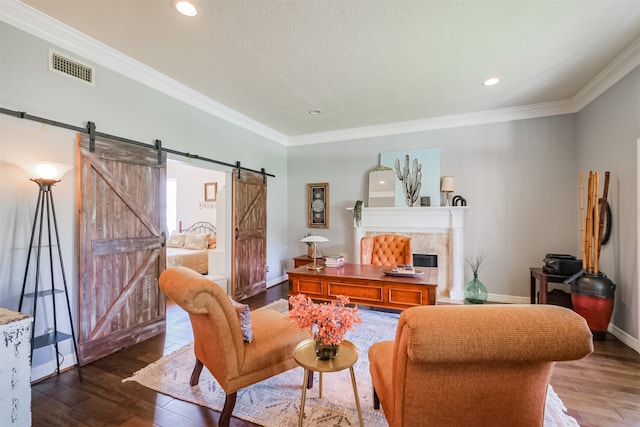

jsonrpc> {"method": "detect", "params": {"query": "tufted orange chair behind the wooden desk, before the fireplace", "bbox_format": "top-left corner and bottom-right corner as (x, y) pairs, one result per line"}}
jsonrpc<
(360, 234), (413, 267)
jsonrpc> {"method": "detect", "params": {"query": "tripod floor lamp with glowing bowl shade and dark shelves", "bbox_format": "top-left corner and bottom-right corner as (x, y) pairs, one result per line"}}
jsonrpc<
(18, 162), (82, 382)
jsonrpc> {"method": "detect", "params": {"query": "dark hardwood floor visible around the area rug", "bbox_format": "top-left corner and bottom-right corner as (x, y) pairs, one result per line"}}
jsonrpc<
(32, 283), (640, 427)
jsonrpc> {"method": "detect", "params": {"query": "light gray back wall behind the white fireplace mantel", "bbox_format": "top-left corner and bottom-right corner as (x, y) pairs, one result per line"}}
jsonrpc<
(288, 115), (579, 302)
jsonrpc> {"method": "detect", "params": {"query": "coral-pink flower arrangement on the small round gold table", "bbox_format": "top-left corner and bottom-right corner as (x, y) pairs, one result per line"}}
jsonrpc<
(288, 294), (362, 345)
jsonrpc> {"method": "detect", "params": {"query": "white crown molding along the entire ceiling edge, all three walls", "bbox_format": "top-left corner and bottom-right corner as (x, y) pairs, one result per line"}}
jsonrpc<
(0, 0), (640, 146)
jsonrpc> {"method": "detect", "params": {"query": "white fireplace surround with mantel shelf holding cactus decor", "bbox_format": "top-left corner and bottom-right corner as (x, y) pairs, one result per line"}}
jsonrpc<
(349, 206), (468, 302)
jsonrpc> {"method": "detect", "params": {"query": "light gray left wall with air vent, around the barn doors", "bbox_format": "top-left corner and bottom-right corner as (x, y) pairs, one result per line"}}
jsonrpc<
(0, 22), (287, 378)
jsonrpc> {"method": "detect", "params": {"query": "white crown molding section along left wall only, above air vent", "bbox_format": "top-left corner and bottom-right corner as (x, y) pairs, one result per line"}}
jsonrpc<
(0, 0), (288, 145)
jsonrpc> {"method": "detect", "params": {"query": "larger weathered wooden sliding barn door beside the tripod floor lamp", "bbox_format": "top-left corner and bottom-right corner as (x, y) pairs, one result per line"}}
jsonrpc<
(78, 137), (166, 365)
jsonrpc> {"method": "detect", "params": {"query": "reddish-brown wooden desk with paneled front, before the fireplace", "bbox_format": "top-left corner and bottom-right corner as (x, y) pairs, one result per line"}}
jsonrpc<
(287, 264), (438, 310)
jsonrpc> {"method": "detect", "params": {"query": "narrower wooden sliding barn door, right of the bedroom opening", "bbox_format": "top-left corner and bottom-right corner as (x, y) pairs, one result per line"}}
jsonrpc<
(231, 170), (267, 300)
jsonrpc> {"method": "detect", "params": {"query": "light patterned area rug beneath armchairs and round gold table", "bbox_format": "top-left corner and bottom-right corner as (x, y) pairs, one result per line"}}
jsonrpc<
(122, 300), (579, 427)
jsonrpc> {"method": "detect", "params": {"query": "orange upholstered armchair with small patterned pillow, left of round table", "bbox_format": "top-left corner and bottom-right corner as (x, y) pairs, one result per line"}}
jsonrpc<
(160, 267), (309, 426)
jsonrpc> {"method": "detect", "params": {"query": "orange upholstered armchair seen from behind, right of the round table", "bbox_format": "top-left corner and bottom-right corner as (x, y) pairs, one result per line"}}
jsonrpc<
(369, 305), (593, 427)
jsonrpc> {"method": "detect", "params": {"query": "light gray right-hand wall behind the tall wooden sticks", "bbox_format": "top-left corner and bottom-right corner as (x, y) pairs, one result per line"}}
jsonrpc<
(576, 68), (640, 339)
